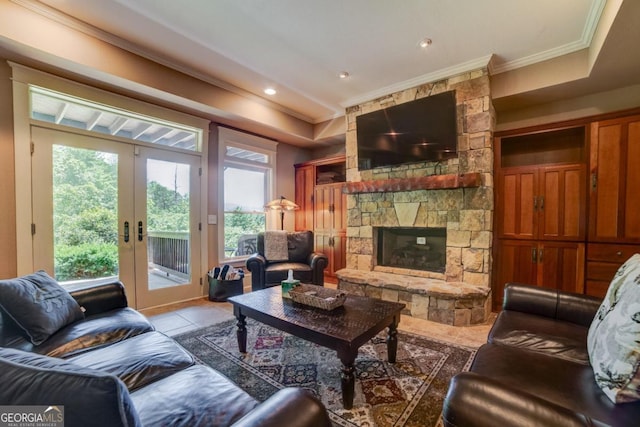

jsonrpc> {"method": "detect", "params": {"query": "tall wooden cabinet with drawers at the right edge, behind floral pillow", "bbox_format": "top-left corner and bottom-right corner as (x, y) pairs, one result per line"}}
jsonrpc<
(586, 115), (640, 296)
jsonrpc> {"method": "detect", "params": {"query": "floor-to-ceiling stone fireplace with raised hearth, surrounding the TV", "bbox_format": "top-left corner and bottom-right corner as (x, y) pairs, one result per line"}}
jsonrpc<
(337, 69), (495, 325)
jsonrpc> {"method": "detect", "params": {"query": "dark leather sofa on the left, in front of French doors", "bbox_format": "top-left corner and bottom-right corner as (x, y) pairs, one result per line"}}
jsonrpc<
(0, 282), (331, 427)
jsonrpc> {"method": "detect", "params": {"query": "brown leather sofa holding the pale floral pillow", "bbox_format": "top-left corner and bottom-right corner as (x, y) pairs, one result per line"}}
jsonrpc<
(443, 284), (640, 427)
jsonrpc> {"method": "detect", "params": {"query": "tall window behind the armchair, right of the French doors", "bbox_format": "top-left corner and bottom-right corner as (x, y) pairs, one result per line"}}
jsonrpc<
(219, 128), (277, 261)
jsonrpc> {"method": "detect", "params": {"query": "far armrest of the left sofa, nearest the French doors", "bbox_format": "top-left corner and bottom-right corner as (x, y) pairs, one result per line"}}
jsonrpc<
(67, 280), (128, 316)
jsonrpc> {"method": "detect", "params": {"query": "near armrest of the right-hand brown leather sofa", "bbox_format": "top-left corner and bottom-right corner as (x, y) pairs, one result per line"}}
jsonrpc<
(442, 372), (607, 427)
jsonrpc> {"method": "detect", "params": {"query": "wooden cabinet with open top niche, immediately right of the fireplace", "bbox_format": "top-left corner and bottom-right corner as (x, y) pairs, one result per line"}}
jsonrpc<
(493, 126), (587, 308)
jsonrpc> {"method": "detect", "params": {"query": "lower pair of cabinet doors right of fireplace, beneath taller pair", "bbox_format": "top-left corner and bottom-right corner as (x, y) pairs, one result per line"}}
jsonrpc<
(494, 240), (585, 307)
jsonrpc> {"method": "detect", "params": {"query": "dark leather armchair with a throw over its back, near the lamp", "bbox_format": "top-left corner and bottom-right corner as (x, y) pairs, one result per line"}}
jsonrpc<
(246, 231), (329, 291)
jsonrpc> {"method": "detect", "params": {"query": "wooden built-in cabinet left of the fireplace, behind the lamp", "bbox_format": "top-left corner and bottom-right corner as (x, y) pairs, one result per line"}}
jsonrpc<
(295, 156), (347, 282)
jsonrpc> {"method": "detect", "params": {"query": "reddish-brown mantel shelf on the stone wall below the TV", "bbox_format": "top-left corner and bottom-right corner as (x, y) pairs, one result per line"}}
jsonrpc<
(344, 172), (482, 194)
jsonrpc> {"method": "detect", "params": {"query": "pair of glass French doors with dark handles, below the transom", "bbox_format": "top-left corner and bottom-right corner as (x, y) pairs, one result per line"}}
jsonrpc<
(31, 126), (202, 308)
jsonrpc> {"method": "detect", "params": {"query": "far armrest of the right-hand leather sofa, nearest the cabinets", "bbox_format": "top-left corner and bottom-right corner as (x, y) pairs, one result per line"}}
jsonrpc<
(502, 283), (601, 327)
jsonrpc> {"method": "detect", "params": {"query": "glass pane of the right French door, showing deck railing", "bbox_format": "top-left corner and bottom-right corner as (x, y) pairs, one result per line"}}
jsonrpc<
(147, 159), (191, 290)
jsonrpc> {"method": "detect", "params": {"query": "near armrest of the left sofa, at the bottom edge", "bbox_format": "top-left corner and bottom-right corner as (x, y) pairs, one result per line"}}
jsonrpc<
(233, 387), (331, 427)
